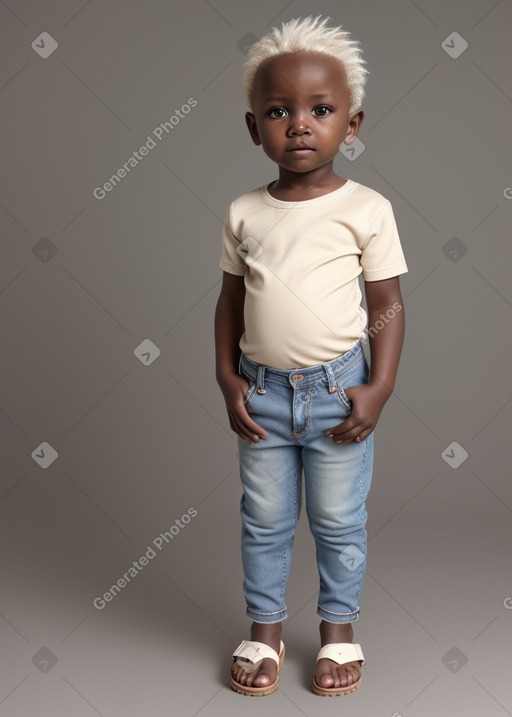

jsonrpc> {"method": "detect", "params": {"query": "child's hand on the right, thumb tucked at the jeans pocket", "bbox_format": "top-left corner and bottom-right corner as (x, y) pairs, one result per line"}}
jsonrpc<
(325, 384), (390, 443)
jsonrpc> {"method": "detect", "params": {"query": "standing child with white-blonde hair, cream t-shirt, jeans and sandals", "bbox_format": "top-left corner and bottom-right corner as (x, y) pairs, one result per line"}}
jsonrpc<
(215, 16), (407, 695)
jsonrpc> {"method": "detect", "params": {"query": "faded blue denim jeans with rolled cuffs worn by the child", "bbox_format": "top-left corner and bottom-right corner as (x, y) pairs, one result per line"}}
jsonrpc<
(238, 342), (373, 623)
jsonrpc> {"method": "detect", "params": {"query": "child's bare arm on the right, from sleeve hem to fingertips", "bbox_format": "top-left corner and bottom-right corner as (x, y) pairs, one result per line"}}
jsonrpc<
(326, 276), (405, 443)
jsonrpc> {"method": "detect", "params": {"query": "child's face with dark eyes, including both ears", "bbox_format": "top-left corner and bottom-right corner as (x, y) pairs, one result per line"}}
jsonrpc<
(246, 52), (364, 173)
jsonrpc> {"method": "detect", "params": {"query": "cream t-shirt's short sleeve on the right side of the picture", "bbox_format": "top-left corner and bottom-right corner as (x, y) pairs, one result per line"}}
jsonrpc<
(360, 201), (408, 281)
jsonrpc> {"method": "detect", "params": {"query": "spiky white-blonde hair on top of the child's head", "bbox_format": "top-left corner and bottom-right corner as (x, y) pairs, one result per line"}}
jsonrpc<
(244, 15), (369, 112)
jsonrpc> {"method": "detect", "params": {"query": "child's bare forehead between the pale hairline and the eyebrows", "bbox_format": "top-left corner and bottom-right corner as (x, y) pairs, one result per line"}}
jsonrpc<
(253, 52), (348, 102)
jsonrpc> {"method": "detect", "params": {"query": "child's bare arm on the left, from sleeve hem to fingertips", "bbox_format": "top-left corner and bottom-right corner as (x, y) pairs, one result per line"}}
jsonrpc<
(215, 271), (267, 442)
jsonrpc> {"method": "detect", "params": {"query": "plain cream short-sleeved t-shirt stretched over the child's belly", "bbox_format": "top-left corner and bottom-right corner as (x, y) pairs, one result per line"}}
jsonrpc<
(219, 179), (407, 369)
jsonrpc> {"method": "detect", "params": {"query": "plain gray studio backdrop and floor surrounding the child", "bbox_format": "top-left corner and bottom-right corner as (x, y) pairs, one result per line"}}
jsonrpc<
(0, 0), (512, 717)
